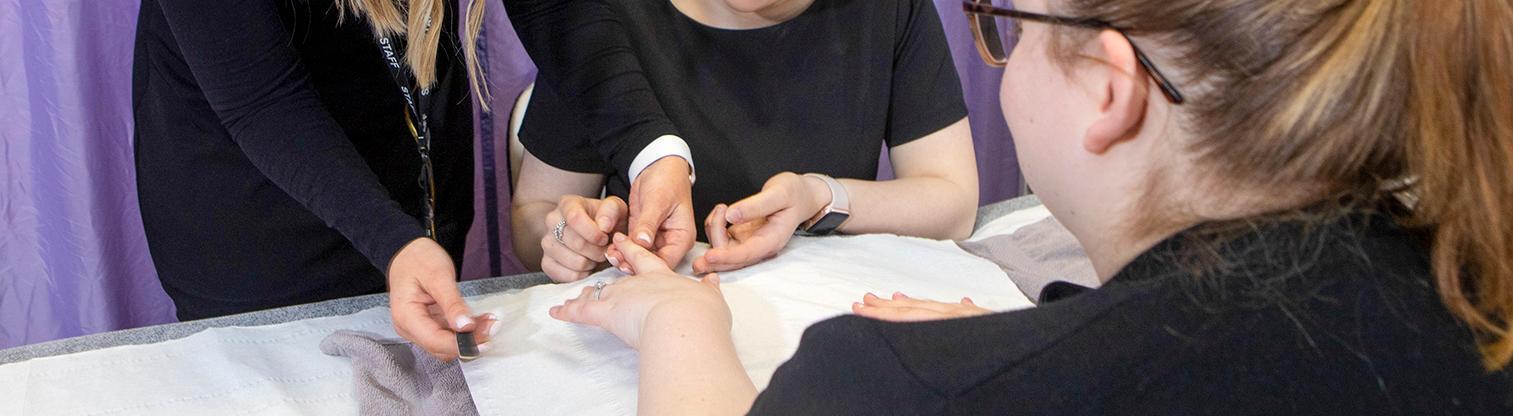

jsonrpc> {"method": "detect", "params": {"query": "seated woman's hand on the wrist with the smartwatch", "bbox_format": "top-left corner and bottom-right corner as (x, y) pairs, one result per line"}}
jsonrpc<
(693, 172), (831, 274)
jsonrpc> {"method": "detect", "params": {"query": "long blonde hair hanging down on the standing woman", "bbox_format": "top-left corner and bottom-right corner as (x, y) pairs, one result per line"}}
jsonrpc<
(336, 0), (489, 110)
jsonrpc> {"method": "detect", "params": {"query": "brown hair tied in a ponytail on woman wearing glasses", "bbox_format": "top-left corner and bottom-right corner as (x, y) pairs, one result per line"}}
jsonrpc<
(1056, 0), (1513, 369)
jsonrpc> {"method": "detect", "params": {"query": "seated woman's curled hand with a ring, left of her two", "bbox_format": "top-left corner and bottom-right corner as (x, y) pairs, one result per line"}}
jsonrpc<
(542, 195), (626, 283)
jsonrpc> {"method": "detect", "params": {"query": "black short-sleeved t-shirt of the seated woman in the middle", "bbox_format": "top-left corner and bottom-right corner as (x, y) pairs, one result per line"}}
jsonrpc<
(520, 0), (967, 233)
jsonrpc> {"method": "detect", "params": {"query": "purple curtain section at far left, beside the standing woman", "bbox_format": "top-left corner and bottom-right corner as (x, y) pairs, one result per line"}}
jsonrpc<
(0, 0), (174, 348)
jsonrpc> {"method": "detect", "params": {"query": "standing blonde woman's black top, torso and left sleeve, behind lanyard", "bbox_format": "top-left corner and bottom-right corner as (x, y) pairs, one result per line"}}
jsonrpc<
(132, 0), (472, 319)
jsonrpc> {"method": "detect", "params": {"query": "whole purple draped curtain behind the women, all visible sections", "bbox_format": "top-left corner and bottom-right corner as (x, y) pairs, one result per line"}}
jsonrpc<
(0, 0), (1020, 348)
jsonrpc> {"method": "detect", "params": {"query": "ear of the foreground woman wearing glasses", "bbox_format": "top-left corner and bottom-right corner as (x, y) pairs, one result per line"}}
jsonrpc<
(1082, 30), (1150, 154)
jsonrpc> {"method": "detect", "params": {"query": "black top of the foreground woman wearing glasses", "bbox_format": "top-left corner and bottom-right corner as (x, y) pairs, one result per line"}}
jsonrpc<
(752, 207), (1513, 414)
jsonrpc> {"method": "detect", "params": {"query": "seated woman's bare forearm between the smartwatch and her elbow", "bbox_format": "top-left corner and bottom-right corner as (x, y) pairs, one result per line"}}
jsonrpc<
(820, 177), (977, 239)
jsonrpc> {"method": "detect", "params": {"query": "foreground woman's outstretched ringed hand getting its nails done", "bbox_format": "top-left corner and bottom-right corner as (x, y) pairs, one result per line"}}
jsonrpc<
(548, 234), (731, 349)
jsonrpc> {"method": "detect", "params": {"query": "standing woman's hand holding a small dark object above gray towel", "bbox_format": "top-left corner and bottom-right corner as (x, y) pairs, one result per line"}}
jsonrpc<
(389, 237), (499, 362)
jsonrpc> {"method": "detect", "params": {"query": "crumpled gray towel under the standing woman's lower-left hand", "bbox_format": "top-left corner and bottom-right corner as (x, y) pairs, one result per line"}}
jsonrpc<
(321, 330), (478, 414)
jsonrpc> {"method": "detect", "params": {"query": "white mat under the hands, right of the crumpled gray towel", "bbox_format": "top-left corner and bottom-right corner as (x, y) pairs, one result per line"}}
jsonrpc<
(463, 232), (1044, 414)
